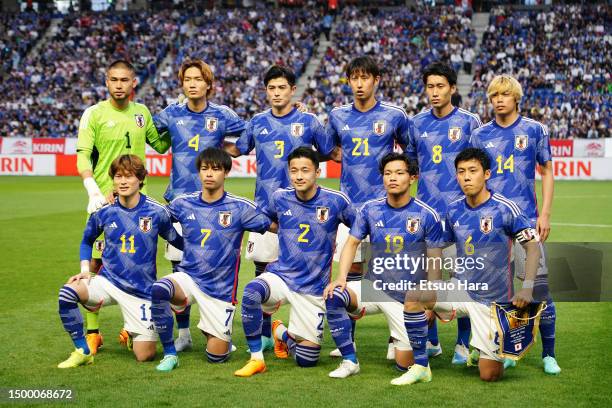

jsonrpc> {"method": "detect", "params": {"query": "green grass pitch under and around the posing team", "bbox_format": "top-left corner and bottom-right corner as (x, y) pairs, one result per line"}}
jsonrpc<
(0, 177), (612, 407)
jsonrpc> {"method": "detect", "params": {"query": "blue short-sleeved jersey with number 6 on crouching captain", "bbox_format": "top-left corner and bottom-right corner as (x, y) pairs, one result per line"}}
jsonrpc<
(446, 192), (531, 304)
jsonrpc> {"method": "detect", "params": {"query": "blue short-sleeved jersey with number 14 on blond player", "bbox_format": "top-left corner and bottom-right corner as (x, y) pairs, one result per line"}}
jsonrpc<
(471, 116), (552, 223)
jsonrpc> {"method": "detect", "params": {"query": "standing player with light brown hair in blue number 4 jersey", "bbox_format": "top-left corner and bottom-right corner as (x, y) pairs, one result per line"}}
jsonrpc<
(153, 59), (245, 351)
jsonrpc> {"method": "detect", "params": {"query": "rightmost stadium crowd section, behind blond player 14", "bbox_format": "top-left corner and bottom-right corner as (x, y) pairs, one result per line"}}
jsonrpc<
(467, 4), (612, 139)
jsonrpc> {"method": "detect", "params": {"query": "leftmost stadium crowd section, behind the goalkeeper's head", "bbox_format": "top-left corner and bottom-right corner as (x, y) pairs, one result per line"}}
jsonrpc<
(0, 11), (183, 137)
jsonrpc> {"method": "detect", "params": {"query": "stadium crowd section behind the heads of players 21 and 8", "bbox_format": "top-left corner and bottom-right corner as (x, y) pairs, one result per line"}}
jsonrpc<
(305, 6), (476, 119)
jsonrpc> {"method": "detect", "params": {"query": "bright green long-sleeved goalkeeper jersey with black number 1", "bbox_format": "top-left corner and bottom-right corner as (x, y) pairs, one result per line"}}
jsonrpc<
(77, 100), (170, 195)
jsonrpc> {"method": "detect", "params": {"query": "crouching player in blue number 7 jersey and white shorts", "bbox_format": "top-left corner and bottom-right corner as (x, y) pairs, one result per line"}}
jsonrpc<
(151, 147), (271, 371)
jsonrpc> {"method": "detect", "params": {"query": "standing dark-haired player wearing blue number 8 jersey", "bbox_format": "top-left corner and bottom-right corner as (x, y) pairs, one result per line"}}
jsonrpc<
(406, 62), (482, 364)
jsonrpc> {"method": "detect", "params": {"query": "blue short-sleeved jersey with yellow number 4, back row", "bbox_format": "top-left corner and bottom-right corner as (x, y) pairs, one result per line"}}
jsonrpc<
(153, 102), (245, 202)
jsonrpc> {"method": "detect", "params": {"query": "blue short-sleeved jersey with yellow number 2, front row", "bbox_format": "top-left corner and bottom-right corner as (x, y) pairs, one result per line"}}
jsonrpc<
(265, 186), (355, 296)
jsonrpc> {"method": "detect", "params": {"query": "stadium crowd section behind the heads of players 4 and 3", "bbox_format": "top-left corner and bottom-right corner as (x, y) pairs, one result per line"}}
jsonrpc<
(145, 9), (322, 117)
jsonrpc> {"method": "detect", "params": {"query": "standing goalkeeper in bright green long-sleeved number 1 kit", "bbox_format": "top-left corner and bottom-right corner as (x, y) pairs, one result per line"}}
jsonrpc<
(77, 60), (170, 354)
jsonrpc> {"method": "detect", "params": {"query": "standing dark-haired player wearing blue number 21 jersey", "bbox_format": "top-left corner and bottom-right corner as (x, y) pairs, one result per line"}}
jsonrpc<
(327, 56), (416, 359)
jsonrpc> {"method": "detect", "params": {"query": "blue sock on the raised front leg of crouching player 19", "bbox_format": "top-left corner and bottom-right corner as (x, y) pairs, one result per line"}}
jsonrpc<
(325, 288), (357, 363)
